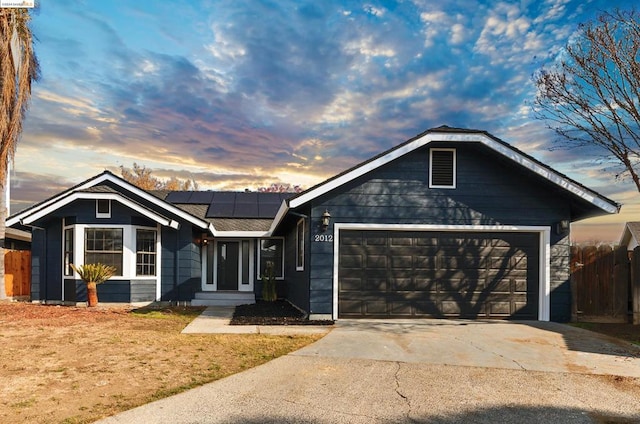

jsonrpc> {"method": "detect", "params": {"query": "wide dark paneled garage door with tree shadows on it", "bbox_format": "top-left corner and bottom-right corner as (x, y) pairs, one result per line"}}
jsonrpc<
(338, 230), (539, 320)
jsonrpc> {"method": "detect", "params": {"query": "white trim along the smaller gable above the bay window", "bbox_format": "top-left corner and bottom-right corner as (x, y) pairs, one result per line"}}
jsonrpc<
(7, 172), (213, 230)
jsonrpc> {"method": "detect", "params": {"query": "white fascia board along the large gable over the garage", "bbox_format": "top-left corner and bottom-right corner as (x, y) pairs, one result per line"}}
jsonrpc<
(289, 132), (618, 213)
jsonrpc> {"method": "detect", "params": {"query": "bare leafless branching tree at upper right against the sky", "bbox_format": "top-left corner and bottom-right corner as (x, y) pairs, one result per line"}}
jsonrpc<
(533, 10), (640, 191)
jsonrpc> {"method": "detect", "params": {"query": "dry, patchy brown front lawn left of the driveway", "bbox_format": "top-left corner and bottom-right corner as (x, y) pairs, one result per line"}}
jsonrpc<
(0, 303), (321, 423)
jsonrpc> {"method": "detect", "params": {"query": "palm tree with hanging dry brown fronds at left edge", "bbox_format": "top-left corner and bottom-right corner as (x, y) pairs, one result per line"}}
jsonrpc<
(0, 8), (39, 299)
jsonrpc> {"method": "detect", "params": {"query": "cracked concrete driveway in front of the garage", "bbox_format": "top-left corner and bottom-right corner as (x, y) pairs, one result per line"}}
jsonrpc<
(97, 320), (640, 424)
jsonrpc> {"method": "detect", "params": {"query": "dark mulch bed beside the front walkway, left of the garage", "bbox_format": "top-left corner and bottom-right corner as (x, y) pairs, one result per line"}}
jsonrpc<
(230, 300), (333, 325)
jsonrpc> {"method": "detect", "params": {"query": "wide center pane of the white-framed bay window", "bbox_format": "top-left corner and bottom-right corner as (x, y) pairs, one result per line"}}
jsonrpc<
(84, 228), (123, 275)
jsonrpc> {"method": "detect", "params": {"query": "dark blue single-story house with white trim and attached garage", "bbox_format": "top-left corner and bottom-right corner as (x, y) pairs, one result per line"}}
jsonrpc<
(7, 126), (619, 321)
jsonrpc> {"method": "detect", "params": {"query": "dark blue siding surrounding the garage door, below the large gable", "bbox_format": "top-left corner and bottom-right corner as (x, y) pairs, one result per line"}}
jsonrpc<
(309, 143), (571, 321)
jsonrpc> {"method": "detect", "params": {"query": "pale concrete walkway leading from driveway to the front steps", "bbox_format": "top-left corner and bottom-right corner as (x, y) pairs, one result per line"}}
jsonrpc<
(182, 306), (333, 336)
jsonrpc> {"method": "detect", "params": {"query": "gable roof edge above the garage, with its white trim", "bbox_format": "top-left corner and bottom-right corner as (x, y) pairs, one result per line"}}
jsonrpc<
(271, 126), (620, 231)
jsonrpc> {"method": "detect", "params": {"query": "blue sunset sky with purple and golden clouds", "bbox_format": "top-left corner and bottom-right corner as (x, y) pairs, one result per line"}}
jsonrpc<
(11, 0), (640, 242)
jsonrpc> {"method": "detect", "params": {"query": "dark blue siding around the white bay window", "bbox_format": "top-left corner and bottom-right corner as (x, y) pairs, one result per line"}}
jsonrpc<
(32, 195), (201, 302)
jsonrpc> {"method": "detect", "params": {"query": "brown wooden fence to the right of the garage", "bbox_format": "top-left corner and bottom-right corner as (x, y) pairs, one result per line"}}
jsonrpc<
(571, 246), (640, 324)
